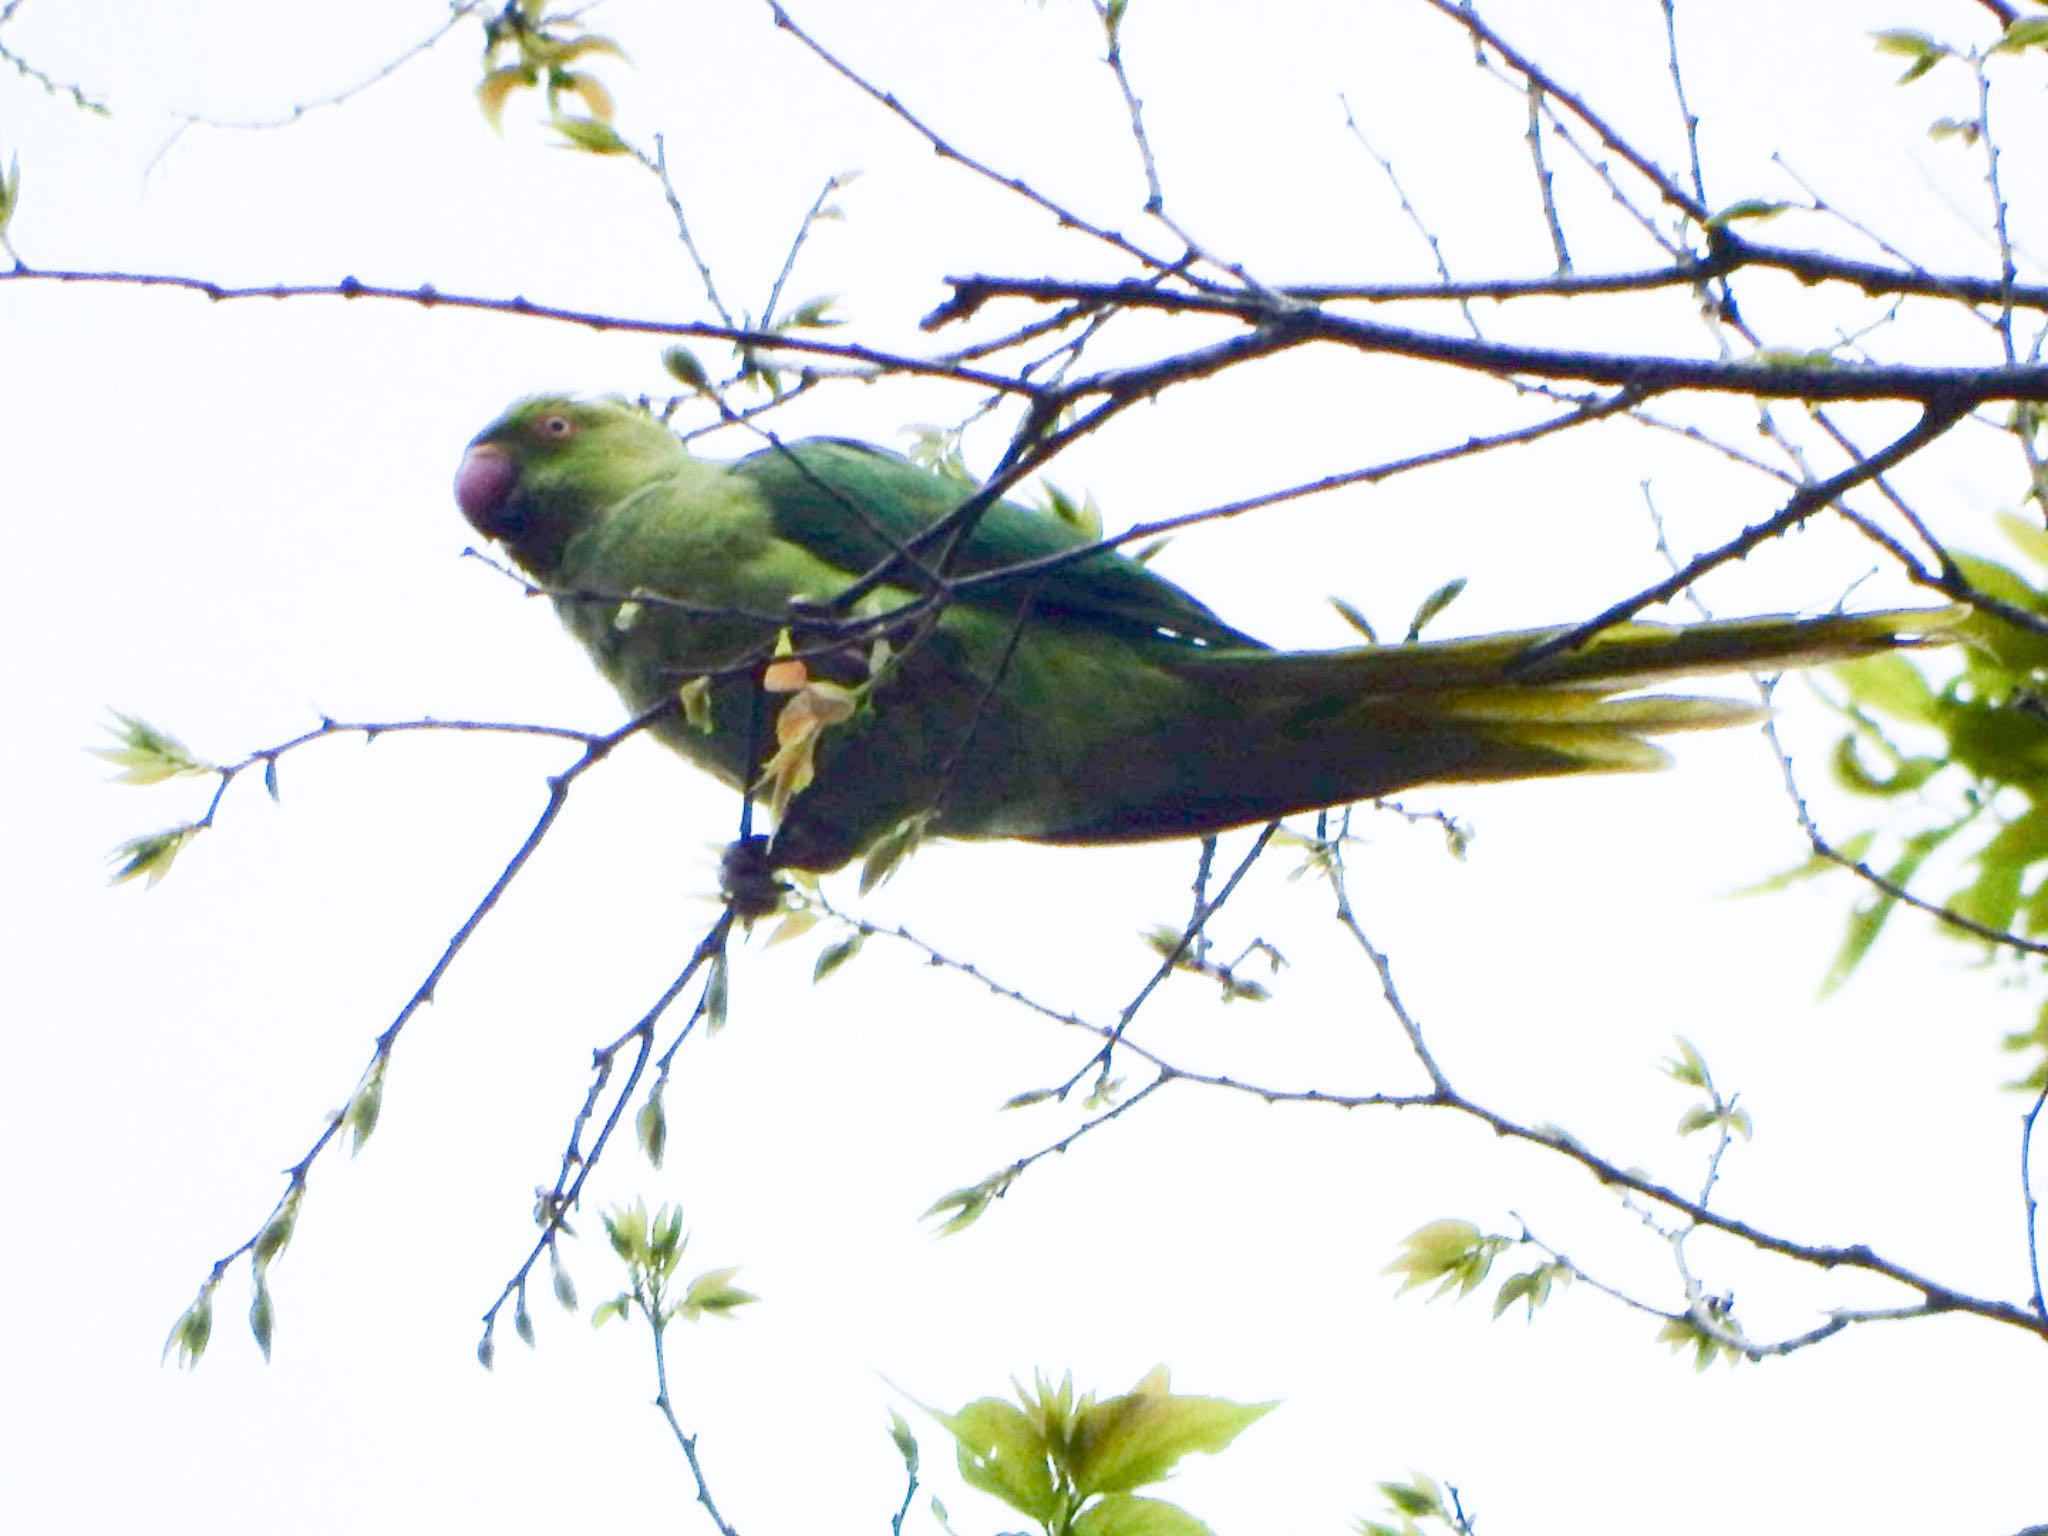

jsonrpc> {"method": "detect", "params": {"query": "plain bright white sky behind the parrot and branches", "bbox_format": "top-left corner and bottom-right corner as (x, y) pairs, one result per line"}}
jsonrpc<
(0, 0), (2048, 1536)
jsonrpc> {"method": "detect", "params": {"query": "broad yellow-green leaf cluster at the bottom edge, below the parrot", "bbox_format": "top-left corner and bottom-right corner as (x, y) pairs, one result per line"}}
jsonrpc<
(925, 1368), (1274, 1536)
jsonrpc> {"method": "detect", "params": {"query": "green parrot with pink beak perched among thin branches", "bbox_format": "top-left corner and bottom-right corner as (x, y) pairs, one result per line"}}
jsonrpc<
(455, 395), (1962, 870)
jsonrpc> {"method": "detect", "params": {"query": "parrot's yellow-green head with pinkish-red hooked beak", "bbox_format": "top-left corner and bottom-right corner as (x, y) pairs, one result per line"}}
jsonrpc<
(455, 395), (682, 582)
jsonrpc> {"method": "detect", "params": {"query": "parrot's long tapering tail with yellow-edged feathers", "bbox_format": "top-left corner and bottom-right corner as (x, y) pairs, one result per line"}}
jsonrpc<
(1069, 608), (1968, 840)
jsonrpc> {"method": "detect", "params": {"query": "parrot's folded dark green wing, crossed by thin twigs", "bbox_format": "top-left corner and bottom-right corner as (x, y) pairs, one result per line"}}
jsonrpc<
(731, 438), (1260, 647)
